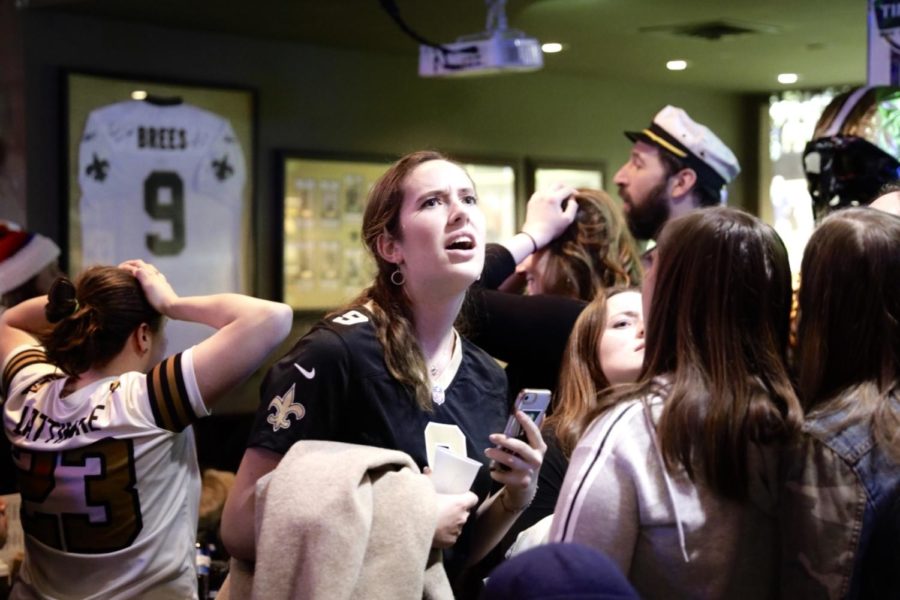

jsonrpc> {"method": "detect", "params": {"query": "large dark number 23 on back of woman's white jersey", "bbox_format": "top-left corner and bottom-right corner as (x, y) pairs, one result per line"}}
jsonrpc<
(17, 438), (143, 554)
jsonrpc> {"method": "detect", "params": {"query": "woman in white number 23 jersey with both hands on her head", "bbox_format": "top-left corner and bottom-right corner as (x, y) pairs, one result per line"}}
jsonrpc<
(0, 260), (292, 599)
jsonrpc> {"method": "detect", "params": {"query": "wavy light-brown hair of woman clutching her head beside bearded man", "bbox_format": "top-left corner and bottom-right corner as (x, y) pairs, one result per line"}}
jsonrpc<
(535, 189), (642, 302)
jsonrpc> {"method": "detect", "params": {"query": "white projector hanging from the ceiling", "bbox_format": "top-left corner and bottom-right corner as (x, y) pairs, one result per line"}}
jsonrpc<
(419, 0), (544, 77)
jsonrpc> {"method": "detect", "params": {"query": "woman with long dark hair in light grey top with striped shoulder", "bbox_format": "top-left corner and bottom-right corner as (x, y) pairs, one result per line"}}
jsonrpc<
(550, 208), (800, 598)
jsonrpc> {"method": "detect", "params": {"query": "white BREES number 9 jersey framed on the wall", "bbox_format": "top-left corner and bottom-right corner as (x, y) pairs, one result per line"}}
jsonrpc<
(78, 100), (246, 352)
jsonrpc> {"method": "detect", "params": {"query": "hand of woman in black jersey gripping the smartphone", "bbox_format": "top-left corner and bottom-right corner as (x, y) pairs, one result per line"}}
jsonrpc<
(484, 410), (547, 506)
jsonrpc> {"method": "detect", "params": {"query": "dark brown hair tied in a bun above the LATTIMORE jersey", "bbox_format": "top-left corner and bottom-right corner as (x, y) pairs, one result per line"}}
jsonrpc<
(41, 267), (163, 375)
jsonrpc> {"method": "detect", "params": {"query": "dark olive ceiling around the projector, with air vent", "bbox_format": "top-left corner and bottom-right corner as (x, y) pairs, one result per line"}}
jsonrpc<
(19, 0), (867, 92)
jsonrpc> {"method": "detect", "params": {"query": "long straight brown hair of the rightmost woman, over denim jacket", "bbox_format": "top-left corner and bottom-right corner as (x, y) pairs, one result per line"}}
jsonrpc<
(797, 208), (900, 461)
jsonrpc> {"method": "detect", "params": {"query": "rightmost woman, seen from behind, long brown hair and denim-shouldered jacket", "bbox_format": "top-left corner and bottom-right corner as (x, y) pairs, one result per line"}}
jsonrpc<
(782, 208), (900, 598)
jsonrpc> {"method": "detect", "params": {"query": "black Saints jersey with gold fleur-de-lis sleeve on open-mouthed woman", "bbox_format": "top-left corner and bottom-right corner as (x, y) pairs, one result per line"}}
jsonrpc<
(249, 307), (508, 488)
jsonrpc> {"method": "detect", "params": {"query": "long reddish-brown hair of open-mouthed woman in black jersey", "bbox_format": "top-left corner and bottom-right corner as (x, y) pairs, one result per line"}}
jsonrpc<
(351, 150), (468, 410)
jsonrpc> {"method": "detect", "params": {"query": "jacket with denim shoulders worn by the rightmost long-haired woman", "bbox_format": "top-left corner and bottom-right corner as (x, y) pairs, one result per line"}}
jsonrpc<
(781, 398), (900, 598)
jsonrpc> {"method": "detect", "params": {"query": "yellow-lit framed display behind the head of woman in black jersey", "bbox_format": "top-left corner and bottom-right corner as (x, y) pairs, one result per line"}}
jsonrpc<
(279, 151), (516, 311)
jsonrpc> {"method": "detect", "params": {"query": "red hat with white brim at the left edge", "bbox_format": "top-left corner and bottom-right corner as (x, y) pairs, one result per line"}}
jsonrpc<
(0, 221), (59, 294)
